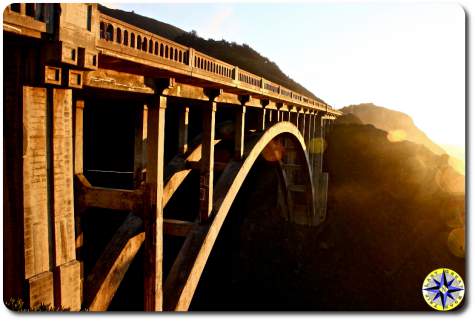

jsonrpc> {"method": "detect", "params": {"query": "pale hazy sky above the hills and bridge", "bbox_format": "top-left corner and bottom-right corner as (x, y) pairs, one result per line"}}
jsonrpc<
(106, 2), (465, 145)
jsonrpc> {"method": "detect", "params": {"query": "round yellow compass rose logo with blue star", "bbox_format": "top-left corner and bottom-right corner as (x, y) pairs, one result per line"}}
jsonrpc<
(422, 268), (465, 311)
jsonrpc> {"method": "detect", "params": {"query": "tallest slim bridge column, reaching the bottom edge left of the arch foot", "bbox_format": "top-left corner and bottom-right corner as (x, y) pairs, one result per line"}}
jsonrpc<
(144, 96), (167, 311)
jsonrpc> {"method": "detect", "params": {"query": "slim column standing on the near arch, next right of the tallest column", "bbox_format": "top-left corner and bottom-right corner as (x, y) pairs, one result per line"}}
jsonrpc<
(200, 98), (217, 222)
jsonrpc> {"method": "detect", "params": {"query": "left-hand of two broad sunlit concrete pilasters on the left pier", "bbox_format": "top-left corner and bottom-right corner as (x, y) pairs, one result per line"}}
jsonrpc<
(19, 86), (54, 307)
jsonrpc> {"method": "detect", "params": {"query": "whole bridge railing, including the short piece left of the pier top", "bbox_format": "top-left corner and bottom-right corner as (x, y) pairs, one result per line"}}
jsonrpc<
(13, 10), (331, 114)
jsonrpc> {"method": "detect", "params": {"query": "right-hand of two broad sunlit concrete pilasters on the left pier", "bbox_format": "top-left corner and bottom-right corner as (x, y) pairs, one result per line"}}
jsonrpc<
(52, 88), (81, 311)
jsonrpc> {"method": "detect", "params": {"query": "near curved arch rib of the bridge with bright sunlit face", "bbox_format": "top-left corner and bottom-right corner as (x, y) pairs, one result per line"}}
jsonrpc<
(163, 122), (315, 311)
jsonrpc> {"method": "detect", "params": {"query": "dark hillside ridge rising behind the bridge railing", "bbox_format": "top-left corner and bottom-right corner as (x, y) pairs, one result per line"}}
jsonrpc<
(99, 5), (322, 101)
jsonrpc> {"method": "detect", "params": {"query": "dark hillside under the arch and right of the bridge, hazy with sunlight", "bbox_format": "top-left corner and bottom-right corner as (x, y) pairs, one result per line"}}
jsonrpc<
(192, 115), (466, 311)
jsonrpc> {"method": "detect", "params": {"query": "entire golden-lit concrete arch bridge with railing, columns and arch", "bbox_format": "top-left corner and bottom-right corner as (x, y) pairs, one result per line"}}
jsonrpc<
(3, 4), (340, 311)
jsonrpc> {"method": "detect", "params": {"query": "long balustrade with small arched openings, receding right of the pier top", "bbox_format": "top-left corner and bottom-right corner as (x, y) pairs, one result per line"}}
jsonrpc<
(96, 13), (342, 114)
